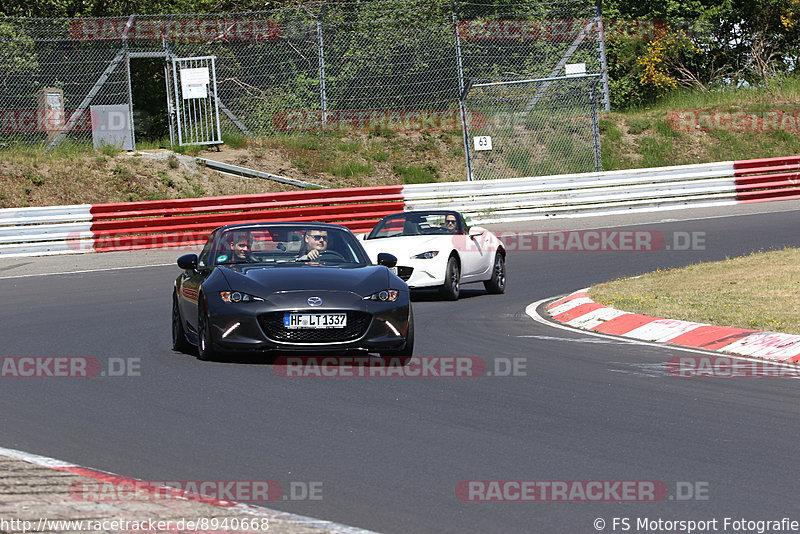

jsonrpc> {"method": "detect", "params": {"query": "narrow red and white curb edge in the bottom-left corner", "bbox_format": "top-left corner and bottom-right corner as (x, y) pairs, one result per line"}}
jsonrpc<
(0, 447), (377, 534)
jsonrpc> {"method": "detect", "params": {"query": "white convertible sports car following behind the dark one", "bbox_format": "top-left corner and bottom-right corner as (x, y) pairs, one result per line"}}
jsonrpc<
(360, 210), (506, 300)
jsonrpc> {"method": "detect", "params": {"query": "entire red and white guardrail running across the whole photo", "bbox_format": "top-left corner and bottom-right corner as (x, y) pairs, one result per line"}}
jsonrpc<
(0, 156), (800, 257)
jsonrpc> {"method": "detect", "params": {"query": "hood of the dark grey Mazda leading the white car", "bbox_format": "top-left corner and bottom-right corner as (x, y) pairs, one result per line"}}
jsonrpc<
(218, 264), (392, 297)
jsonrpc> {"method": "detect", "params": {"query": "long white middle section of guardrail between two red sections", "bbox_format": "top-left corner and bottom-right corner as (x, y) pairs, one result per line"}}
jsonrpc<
(403, 162), (736, 223)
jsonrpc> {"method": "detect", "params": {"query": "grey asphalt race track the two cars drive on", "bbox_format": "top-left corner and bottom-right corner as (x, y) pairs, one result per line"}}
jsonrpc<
(0, 204), (800, 533)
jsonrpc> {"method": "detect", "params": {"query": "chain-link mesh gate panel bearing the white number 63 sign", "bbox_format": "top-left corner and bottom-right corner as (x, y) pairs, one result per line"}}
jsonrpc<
(465, 74), (602, 180)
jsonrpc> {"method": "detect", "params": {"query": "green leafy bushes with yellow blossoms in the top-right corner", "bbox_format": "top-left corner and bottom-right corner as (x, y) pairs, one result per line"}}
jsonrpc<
(603, 0), (800, 108)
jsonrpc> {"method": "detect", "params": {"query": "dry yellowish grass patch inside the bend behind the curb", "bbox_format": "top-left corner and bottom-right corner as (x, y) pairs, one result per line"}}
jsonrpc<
(589, 248), (800, 334)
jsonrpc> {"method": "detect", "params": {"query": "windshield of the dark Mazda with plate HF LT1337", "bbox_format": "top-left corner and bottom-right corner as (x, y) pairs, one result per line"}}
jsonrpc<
(209, 224), (369, 266)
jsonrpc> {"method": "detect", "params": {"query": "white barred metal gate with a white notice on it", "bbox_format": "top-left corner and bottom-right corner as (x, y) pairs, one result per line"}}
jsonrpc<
(167, 56), (222, 145)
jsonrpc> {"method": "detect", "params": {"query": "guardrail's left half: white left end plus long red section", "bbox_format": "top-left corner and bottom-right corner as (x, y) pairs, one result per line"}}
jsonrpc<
(0, 186), (404, 257)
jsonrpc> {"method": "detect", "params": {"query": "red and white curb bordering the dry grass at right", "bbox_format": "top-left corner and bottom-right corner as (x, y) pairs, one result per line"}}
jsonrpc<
(546, 288), (800, 362)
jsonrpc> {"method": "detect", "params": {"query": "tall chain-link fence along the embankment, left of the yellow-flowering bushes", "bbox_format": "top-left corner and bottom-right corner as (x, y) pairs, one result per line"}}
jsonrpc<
(0, 0), (603, 179)
